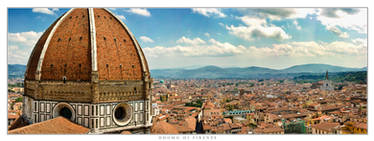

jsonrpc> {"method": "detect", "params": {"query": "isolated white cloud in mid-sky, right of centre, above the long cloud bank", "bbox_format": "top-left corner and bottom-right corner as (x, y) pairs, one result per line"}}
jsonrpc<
(226, 16), (292, 41)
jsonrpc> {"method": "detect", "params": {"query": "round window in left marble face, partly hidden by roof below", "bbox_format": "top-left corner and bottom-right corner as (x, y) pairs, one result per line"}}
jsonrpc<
(53, 102), (75, 121)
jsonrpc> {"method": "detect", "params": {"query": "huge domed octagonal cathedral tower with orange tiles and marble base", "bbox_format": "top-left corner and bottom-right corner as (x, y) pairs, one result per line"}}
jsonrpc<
(23, 8), (151, 133)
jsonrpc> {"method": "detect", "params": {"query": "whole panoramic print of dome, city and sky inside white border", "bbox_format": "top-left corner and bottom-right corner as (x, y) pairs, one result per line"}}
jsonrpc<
(4, 8), (368, 135)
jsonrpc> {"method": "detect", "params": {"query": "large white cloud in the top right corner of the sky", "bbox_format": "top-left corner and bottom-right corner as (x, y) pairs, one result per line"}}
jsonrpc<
(317, 8), (367, 34)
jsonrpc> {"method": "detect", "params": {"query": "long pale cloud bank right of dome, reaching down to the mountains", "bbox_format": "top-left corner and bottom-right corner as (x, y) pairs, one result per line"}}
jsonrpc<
(143, 38), (367, 69)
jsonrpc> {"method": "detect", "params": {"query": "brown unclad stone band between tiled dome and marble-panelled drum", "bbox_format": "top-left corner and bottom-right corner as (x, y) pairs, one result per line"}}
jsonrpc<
(25, 80), (149, 103)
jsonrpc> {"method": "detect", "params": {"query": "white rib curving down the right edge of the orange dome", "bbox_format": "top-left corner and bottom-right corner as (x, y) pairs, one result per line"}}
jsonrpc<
(104, 8), (149, 77)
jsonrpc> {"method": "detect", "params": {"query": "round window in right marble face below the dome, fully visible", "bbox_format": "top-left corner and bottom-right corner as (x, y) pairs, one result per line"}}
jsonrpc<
(113, 103), (132, 126)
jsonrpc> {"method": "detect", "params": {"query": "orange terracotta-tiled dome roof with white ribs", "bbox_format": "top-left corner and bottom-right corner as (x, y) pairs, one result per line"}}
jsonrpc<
(25, 8), (149, 81)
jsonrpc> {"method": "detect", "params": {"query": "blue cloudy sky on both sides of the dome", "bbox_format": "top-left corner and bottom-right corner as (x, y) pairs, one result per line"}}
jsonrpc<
(8, 8), (367, 69)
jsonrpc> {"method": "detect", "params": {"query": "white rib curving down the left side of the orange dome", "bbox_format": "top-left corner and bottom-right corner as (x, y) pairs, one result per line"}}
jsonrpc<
(35, 8), (74, 80)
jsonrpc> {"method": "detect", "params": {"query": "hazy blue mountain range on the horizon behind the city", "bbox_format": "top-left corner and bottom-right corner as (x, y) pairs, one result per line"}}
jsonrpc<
(8, 64), (367, 79)
